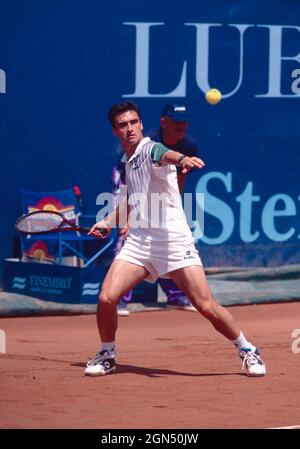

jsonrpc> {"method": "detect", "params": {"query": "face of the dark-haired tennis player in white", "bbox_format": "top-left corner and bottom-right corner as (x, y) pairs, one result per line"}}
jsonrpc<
(113, 111), (143, 148)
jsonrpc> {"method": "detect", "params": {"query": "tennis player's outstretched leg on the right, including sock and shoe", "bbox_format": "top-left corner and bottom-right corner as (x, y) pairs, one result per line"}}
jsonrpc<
(169, 266), (266, 376)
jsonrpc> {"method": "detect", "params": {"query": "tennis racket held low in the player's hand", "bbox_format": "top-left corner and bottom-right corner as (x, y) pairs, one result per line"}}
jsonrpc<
(15, 210), (109, 237)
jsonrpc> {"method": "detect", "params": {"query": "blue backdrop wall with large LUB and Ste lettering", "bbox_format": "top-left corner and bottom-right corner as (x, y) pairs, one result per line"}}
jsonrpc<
(0, 0), (300, 265)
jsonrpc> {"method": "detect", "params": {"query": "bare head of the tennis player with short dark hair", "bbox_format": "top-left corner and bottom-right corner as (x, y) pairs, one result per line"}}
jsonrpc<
(108, 101), (143, 150)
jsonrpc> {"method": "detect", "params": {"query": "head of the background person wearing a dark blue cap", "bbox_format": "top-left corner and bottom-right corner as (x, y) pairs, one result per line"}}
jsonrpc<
(160, 104), (188, 144)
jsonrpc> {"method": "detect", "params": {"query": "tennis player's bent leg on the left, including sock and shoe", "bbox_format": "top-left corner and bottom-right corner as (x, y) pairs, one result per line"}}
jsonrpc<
(85, 259), (149, 376)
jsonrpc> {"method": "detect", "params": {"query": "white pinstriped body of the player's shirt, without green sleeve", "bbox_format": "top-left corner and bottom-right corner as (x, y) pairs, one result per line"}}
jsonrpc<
(126, 137), (194, 243)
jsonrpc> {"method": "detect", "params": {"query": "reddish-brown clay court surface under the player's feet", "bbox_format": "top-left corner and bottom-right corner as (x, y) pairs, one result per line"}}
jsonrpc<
(0, 302), (300, 429)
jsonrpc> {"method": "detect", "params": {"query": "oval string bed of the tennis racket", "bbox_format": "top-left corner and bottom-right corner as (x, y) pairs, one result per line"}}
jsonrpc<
(16, 212), (63, 232)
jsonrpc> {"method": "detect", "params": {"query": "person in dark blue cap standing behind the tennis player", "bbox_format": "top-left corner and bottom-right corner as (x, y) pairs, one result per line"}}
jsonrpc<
(112, 103), (198, 316)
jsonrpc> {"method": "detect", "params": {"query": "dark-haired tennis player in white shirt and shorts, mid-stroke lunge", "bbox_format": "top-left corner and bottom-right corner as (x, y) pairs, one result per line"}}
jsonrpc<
(85, 102), (266, 376)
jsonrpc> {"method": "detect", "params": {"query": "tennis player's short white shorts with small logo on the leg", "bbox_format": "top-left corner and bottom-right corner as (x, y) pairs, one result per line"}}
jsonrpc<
(116, 233), (202, 283)
